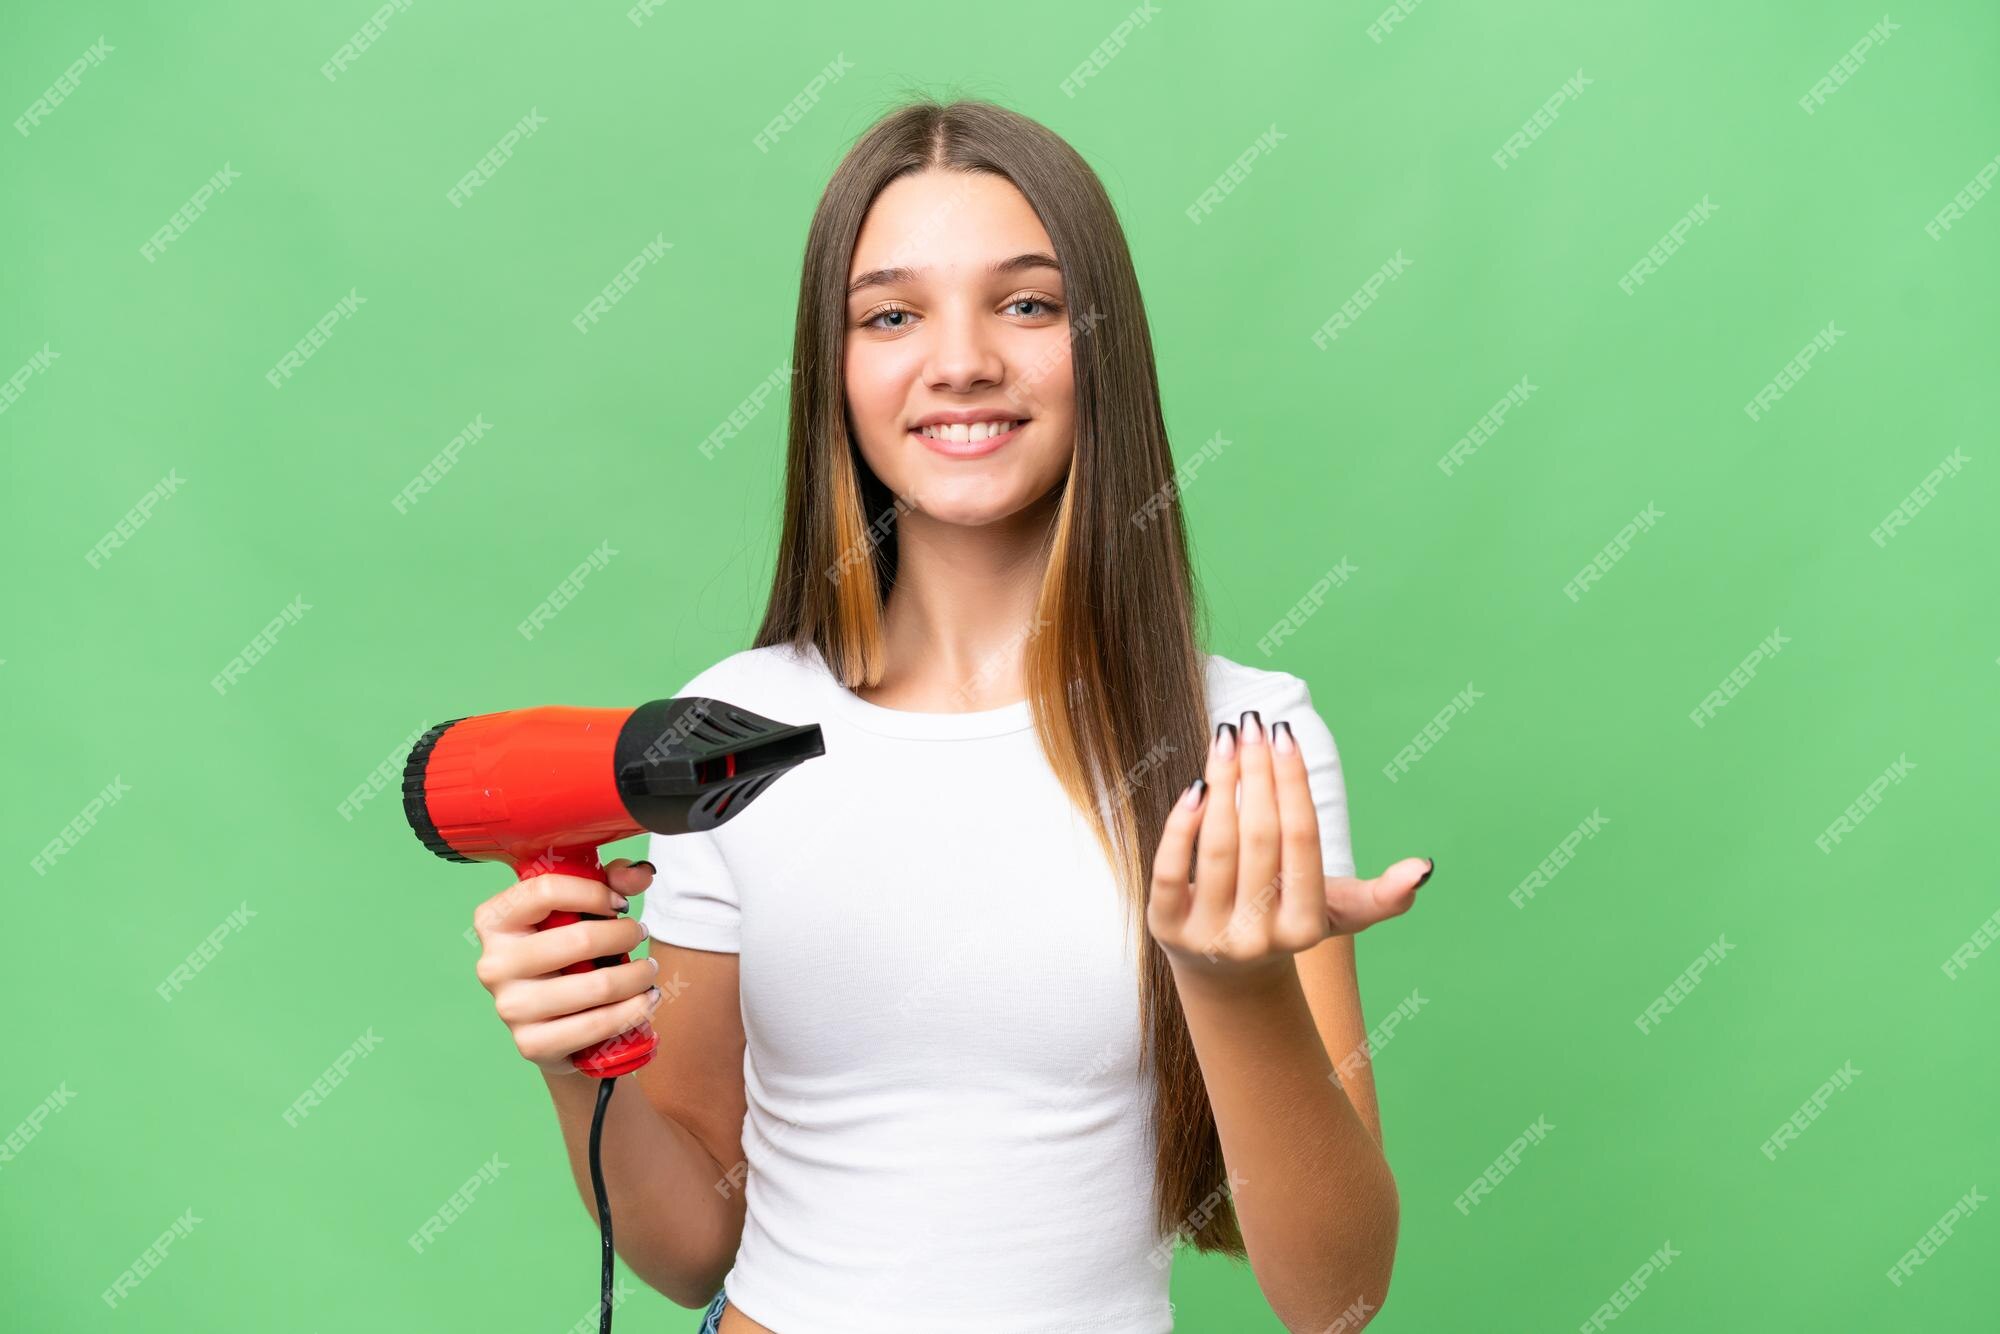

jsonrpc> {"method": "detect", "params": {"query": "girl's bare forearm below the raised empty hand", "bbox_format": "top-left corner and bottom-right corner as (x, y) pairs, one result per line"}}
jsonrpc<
(1174, 964), (1398, 1334)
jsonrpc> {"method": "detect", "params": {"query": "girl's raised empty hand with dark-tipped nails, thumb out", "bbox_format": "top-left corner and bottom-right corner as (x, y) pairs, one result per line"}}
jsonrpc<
(1146, 710), (1434, 980)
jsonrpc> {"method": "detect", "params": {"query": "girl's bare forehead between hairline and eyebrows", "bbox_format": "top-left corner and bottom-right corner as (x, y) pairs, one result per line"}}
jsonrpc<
(848, 170), (1054, 280)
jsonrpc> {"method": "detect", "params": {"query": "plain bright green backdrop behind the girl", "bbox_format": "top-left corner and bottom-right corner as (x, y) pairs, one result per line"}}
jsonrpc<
(0, 0), (2000, 1334)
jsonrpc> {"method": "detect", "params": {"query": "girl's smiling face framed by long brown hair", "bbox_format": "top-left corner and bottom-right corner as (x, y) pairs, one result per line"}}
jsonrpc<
(846, 170), (1076, 526)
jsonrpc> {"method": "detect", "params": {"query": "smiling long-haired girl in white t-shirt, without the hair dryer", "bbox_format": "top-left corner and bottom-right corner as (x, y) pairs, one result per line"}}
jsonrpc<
(480, 100), (1430, 1334)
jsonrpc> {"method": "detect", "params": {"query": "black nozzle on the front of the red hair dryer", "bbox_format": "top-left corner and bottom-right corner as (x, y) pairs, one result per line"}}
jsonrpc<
(614, 694), (826, 834)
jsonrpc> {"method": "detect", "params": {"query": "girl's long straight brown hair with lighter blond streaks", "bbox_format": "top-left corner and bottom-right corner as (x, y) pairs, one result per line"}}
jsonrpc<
(756, 98), (1244, 1258)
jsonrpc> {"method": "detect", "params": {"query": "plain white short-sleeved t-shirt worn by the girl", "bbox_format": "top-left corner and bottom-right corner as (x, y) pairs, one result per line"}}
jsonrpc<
(640, 646), (1354, 1334)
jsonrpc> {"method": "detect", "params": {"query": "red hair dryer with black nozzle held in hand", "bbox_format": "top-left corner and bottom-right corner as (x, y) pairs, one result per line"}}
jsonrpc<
(402, 696), (826, 1080)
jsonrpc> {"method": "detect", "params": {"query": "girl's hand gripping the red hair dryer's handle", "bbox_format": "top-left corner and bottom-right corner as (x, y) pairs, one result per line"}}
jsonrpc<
(472, 858), (660, 1078)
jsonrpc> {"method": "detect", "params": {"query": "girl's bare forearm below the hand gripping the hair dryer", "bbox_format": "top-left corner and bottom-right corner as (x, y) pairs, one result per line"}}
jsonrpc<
(542, 1070), (742, 1306)
